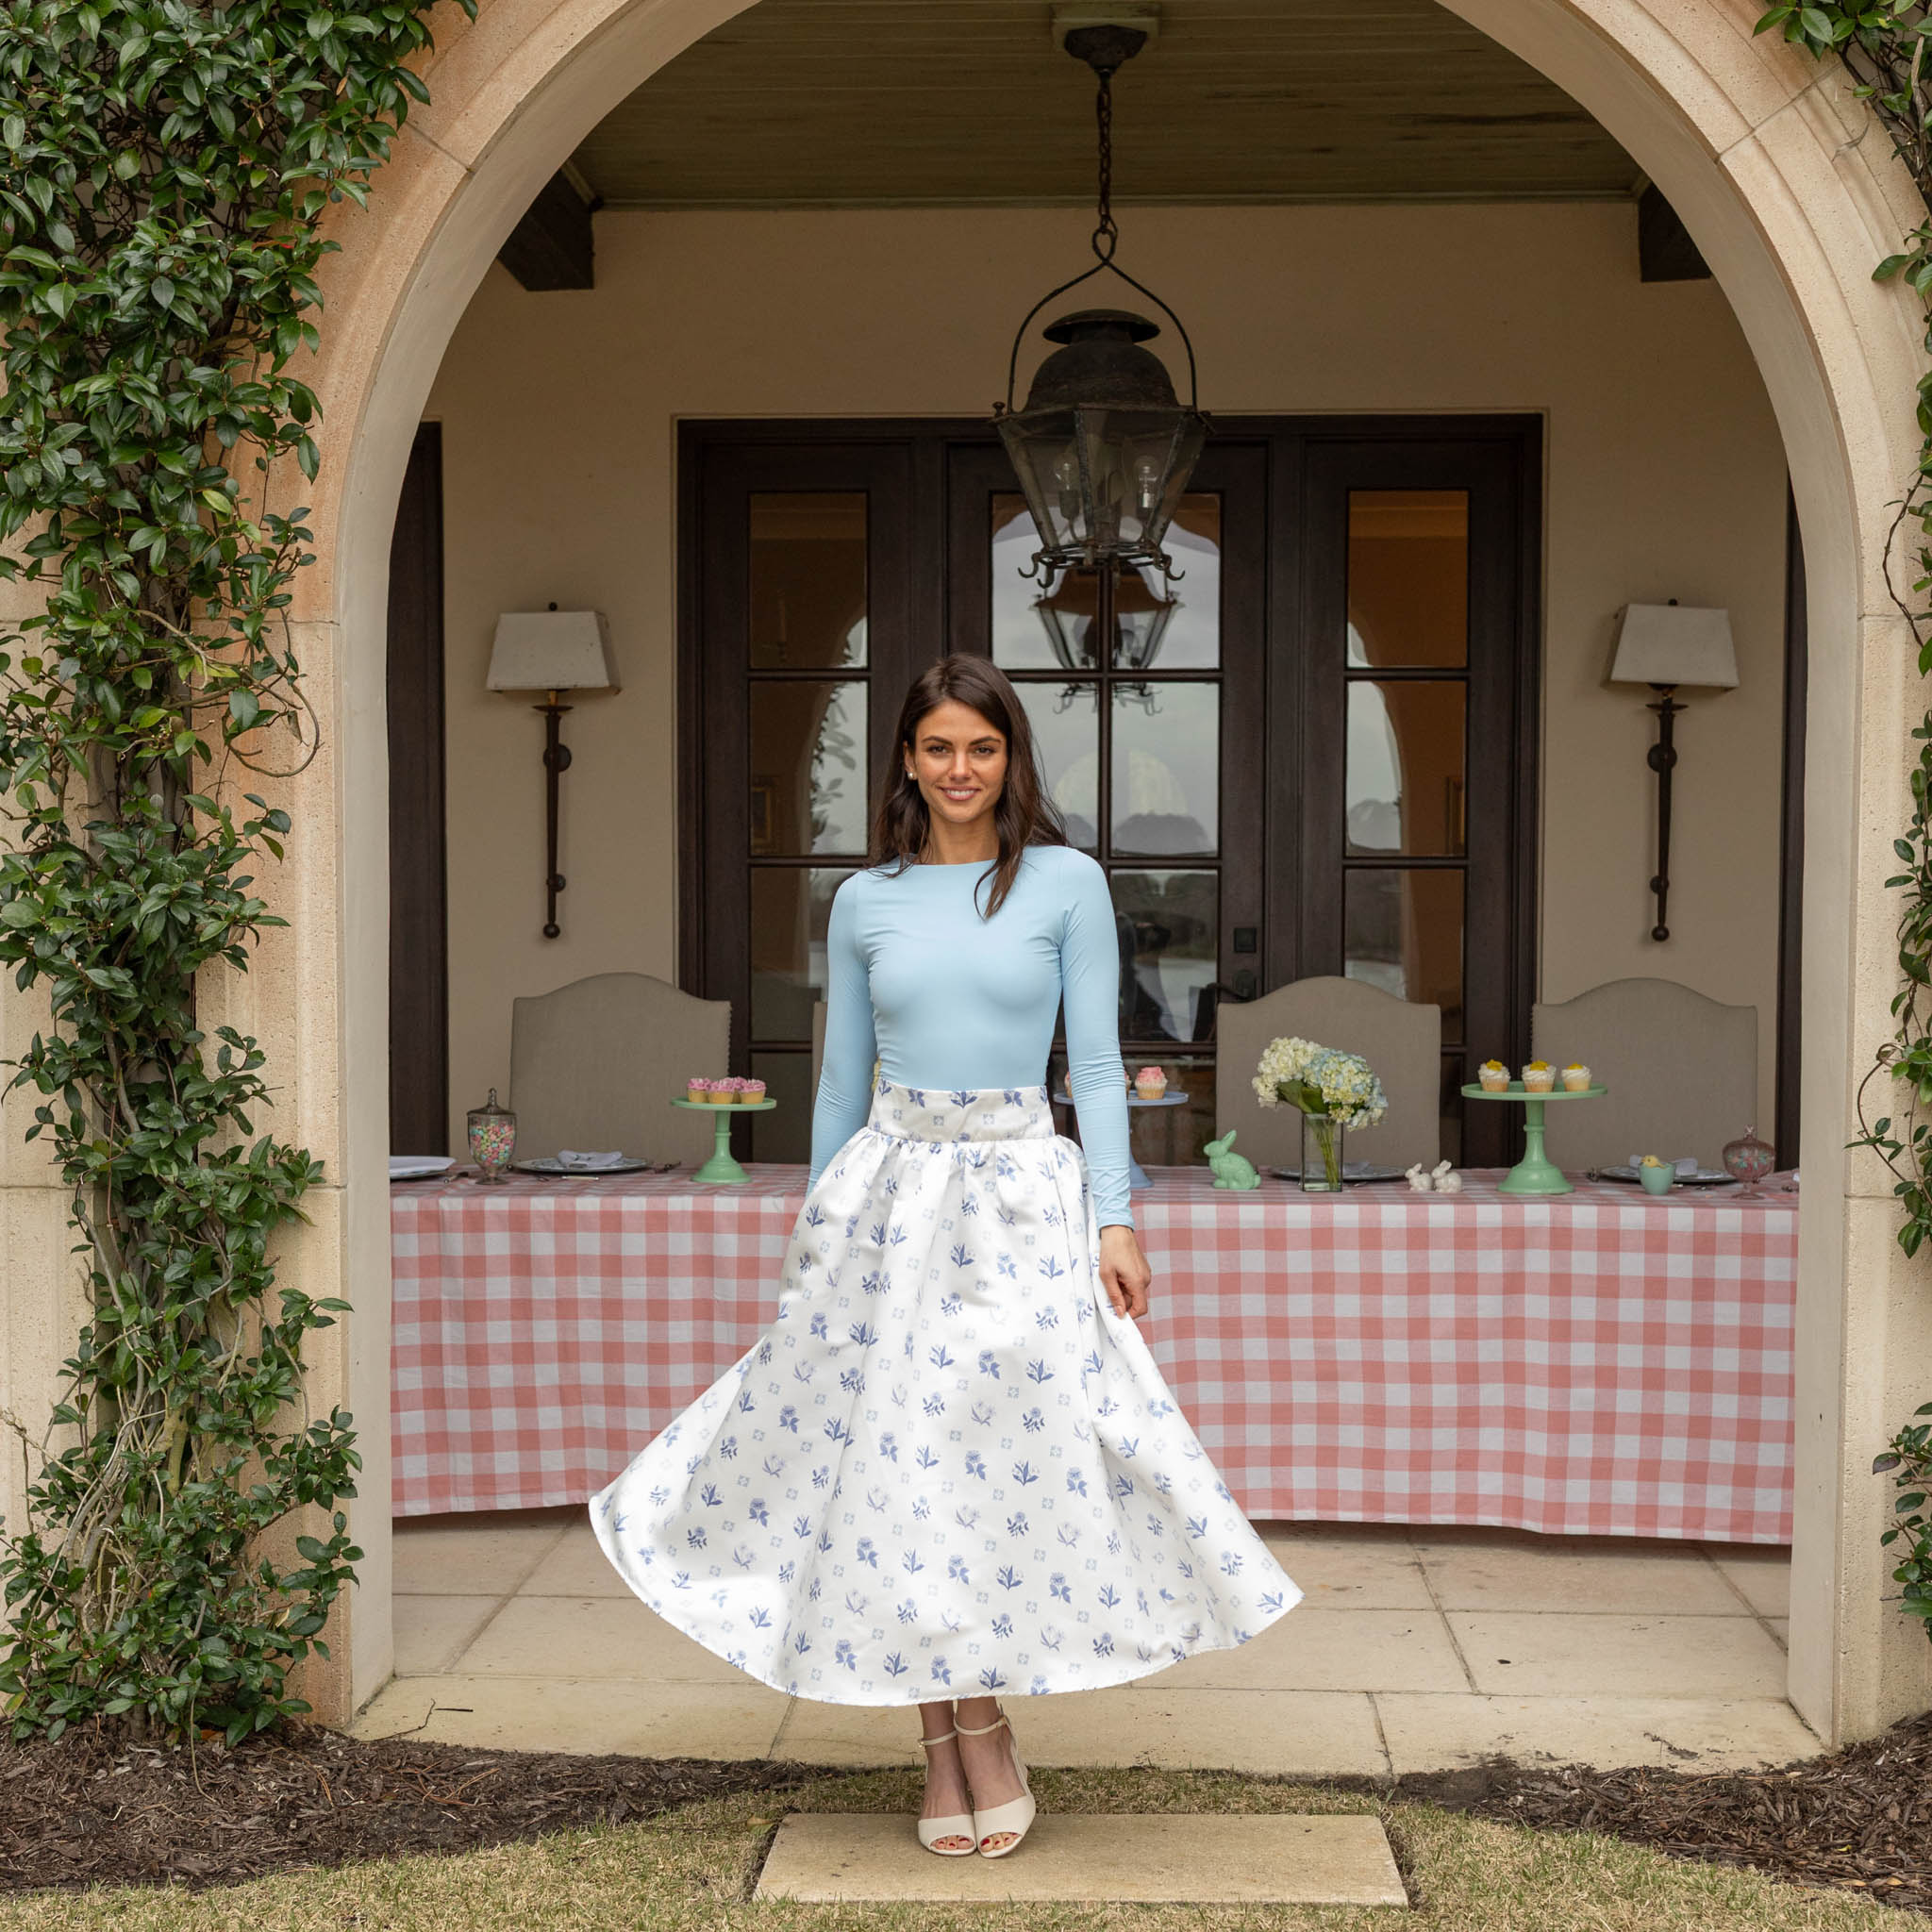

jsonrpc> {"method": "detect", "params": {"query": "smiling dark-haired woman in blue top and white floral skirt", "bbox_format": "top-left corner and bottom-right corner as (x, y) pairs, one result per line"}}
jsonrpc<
(591, 657), (1302, 1857)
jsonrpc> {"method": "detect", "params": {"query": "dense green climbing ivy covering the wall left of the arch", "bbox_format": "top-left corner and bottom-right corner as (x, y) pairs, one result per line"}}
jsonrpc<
(0, 0), (475, 1739)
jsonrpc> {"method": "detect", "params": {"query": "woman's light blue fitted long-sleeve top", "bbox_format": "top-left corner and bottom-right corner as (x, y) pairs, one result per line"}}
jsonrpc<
(811, 846), (1134, 1226)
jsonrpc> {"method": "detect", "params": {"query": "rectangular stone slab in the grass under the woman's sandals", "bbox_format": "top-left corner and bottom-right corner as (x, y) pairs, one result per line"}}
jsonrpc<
(756, 1812), (1408, 1907)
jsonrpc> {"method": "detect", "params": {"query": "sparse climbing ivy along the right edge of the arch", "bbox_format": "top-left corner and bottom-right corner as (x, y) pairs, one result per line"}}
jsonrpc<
(1758, 0), (1932, 1639)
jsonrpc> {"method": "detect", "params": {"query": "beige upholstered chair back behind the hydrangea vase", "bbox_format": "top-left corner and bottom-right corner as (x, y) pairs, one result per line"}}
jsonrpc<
(1215, 974), (1443, 1169)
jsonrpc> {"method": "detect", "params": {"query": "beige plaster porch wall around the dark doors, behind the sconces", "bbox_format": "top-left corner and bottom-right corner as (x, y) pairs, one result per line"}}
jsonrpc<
(427, 205), (1785, 1130)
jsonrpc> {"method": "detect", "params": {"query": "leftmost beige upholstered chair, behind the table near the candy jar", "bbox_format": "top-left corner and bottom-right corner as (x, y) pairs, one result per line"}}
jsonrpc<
(510, 972), (730, 1163)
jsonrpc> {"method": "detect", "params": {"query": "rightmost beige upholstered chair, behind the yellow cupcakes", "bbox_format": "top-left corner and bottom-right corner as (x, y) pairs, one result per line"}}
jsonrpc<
(1530, 979), (1770, 1173)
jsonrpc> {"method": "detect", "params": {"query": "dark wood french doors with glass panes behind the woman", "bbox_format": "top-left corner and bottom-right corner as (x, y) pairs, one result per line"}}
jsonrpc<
(680, 417), (1540, 1161)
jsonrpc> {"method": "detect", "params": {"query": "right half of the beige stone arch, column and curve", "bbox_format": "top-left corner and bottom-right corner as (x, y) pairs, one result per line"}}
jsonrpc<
(1445, 0), (1932, 1742)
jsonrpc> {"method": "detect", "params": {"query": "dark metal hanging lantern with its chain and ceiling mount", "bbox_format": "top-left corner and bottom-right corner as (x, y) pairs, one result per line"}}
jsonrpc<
(995, 25), (1208, 593)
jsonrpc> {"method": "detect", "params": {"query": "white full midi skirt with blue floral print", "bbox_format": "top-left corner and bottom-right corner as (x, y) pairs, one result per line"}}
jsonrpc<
(591, 1082), (1302, 1704)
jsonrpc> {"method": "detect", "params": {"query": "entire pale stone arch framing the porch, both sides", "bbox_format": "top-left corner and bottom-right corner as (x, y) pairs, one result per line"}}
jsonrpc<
(297, 0), (1932, 1744)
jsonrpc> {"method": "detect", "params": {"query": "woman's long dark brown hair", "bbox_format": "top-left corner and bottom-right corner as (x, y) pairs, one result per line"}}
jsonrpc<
(866, 657), (1066, 918)
